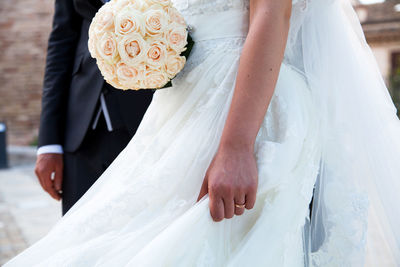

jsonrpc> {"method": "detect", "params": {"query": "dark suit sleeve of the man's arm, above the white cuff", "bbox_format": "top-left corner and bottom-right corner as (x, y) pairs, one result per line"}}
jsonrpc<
(39, 0), (82, 147)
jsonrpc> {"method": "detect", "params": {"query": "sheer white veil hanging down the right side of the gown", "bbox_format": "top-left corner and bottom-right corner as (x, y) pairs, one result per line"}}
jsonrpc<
(293, 0), (400, 266)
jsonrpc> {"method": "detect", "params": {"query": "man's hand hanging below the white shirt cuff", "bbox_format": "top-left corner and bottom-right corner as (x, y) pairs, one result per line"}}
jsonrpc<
(35, 153), (63, 200)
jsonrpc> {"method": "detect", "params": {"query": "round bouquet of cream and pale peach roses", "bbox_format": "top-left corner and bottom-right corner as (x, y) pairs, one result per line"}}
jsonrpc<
(88, 0), (193, 90)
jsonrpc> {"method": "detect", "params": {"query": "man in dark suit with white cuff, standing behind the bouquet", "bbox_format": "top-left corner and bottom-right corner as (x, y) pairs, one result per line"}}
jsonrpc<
(35, 0), (152, 214)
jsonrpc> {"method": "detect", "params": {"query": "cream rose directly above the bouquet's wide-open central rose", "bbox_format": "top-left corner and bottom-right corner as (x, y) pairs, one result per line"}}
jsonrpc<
(115, 7), (146, 35)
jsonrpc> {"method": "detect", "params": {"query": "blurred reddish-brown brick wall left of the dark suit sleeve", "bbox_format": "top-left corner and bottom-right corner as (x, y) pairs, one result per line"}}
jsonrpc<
(0, 0), (54, 145)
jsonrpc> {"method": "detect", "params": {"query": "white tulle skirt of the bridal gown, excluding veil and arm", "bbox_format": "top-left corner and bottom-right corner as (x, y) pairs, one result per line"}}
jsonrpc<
(5, 40), (320, 267)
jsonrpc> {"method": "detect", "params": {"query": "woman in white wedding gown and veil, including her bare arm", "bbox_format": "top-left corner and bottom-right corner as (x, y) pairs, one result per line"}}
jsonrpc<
(5, 0), (400, 267)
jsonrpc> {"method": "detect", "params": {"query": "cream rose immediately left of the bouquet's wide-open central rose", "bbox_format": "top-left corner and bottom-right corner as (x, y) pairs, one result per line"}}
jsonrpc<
(96, 32), (119, 64)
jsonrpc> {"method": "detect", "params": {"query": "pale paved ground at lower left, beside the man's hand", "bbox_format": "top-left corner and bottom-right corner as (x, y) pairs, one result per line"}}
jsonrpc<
(0, 163), (61, 265)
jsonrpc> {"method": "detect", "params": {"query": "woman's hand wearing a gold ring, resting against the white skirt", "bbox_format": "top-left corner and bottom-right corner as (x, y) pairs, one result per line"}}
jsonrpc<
(198, 148), (258, 221)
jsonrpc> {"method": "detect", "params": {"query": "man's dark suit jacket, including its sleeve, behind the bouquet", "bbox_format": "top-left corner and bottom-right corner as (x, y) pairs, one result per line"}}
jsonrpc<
(39, 0), (153, 152)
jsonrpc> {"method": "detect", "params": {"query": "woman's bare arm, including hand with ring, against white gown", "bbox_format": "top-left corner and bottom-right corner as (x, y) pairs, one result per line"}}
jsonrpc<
(199, 0), (292, 221)
